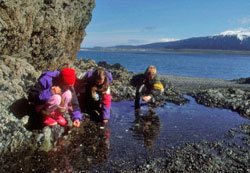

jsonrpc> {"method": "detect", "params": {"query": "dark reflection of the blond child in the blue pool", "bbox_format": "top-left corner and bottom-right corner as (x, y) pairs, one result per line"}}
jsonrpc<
(130, 108), (161, 148)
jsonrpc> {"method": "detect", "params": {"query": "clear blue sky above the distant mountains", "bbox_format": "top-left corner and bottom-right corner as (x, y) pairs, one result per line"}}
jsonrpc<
(81, 0), (250, 48)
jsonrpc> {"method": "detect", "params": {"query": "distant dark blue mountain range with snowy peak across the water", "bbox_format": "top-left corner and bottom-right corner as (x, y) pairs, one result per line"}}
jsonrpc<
(90, 28), (250, 51)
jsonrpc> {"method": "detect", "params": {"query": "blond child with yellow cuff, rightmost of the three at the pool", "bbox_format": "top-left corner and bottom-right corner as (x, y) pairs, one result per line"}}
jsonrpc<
(131, 65), (164, 109)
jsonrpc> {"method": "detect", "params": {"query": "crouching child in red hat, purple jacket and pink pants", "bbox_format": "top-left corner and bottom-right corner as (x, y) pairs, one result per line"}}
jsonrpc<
(28, 68), (82, 127)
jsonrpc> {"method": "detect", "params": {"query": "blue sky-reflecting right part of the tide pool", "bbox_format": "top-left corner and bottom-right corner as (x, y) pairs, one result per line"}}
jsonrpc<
(111, 97), (249, 149)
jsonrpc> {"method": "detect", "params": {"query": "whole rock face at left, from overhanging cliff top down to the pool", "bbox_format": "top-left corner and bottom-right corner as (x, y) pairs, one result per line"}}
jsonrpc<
(0, 0), (95, 153)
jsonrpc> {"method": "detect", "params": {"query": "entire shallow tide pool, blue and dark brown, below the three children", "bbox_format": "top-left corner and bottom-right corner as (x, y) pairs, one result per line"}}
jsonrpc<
(1, 97), (249, 172)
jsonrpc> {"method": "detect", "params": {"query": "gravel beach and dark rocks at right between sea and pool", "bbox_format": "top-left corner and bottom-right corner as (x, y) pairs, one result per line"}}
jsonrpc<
(160, 75), (250, 118)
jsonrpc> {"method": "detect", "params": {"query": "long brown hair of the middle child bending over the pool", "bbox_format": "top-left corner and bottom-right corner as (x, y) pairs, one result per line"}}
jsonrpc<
(90, 68), (109, 92)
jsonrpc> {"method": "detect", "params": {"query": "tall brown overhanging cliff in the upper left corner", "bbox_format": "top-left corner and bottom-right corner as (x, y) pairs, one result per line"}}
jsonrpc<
(0, 0), (95, 70)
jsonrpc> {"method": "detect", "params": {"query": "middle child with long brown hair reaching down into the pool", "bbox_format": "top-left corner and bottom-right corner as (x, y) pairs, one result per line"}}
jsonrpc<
(79, 68), (113, 123)
